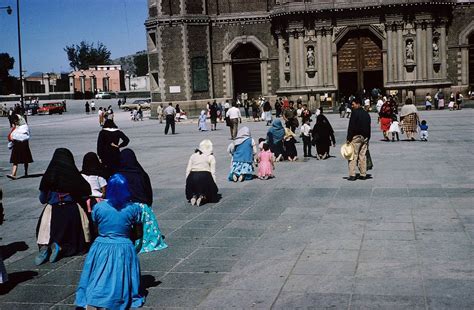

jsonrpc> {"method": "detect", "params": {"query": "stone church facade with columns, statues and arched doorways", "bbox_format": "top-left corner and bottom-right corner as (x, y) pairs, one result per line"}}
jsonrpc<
(145, 0), (474, 106)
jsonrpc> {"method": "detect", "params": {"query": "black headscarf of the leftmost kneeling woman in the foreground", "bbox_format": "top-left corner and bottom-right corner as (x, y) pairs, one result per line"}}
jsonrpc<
(39, 148), (91, 198)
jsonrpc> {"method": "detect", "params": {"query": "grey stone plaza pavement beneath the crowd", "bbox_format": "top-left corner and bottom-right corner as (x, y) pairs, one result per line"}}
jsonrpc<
(0, 102), (474, 310)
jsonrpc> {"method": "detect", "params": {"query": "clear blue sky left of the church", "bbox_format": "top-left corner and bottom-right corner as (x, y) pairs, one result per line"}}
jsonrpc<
(0, 0), (147, 76)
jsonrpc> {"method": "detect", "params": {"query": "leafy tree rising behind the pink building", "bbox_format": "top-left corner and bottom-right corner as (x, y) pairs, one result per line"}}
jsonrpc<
(64, 41), (111, 70)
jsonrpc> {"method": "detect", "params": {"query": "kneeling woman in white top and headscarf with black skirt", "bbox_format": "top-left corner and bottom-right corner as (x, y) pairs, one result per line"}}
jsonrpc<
(186, 139), (219, 207)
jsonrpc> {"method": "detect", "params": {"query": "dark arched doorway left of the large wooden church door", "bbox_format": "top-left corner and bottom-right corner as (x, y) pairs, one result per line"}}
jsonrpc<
(231, 43), (262, 98)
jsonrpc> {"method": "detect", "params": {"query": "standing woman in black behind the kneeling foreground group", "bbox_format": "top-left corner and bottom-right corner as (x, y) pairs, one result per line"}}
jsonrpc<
(97, 119), (130, 177)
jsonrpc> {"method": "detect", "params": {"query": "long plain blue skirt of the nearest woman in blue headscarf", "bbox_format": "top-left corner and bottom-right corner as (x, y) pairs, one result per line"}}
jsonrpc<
(75, 237), (145, 310)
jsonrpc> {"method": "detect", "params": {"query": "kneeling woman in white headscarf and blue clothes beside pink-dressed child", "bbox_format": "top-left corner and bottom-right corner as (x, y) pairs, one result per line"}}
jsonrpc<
(227, 127), (257, 182)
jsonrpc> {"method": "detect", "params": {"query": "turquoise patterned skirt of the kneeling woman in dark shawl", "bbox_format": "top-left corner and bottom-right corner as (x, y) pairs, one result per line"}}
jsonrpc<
(135, 203), (168, 253)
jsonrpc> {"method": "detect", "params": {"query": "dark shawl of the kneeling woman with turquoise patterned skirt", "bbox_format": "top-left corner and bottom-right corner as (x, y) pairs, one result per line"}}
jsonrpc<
(118, 149), (153, 206)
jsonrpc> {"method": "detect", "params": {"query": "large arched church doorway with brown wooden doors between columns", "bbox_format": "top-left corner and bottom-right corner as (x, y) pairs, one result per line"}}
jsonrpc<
(337, 29), (383, 96)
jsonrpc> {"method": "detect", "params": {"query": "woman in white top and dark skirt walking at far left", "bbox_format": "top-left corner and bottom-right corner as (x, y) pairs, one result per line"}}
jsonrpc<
(7, 114), (33, 180)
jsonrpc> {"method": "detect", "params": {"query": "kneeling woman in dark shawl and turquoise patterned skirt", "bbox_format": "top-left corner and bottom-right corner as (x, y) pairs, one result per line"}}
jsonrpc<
(119, 149), (168, 253)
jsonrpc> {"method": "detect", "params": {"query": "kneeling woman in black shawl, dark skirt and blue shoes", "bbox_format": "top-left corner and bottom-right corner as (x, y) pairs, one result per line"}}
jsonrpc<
(35, 148), (91, 265)
